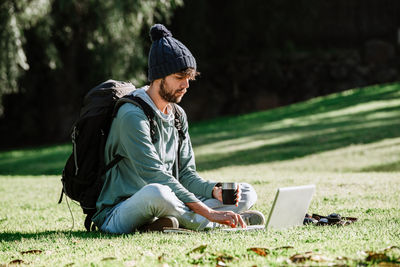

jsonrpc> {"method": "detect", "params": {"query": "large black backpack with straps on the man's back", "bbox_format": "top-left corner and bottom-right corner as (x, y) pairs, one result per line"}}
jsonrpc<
(58, 80), (185, 231)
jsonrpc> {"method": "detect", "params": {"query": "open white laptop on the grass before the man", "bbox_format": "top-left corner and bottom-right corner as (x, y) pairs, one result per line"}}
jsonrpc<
(221, 185), (315, 231)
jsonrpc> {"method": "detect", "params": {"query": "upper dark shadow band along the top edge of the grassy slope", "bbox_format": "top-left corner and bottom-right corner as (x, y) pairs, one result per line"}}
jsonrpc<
(191, 84), (400, 146)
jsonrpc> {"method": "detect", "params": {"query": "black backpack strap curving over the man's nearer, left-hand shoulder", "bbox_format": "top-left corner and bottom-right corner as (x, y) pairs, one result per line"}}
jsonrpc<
(113, 95), (157, 144)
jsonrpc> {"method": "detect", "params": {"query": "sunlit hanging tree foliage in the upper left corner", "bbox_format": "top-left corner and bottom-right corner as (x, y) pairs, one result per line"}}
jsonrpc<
(0, 0), (182, 95)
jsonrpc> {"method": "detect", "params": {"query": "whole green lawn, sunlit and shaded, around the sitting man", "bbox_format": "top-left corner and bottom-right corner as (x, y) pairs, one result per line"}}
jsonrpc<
(0, 84), (400, 266)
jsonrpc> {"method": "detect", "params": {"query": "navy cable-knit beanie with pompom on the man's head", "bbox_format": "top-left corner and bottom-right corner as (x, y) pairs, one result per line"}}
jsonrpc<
(148, 24), (196, 82)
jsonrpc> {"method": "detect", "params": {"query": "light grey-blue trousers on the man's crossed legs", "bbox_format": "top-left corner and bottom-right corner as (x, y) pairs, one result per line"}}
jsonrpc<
(100, 183), (257, 234)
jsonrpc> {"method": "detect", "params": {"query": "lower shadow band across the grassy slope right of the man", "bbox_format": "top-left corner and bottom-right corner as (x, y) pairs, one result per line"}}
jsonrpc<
(196, 119), (400, 171)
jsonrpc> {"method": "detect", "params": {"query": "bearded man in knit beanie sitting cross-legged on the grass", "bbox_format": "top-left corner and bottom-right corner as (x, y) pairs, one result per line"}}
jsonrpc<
(92, 24), (265, 233)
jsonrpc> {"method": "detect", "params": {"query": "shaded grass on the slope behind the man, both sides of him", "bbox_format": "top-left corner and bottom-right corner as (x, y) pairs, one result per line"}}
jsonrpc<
(0, 84), (400, 175)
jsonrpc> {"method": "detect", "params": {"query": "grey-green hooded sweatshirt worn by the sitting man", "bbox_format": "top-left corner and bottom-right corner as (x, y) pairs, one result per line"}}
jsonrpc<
(93, 87), (216, 226)
